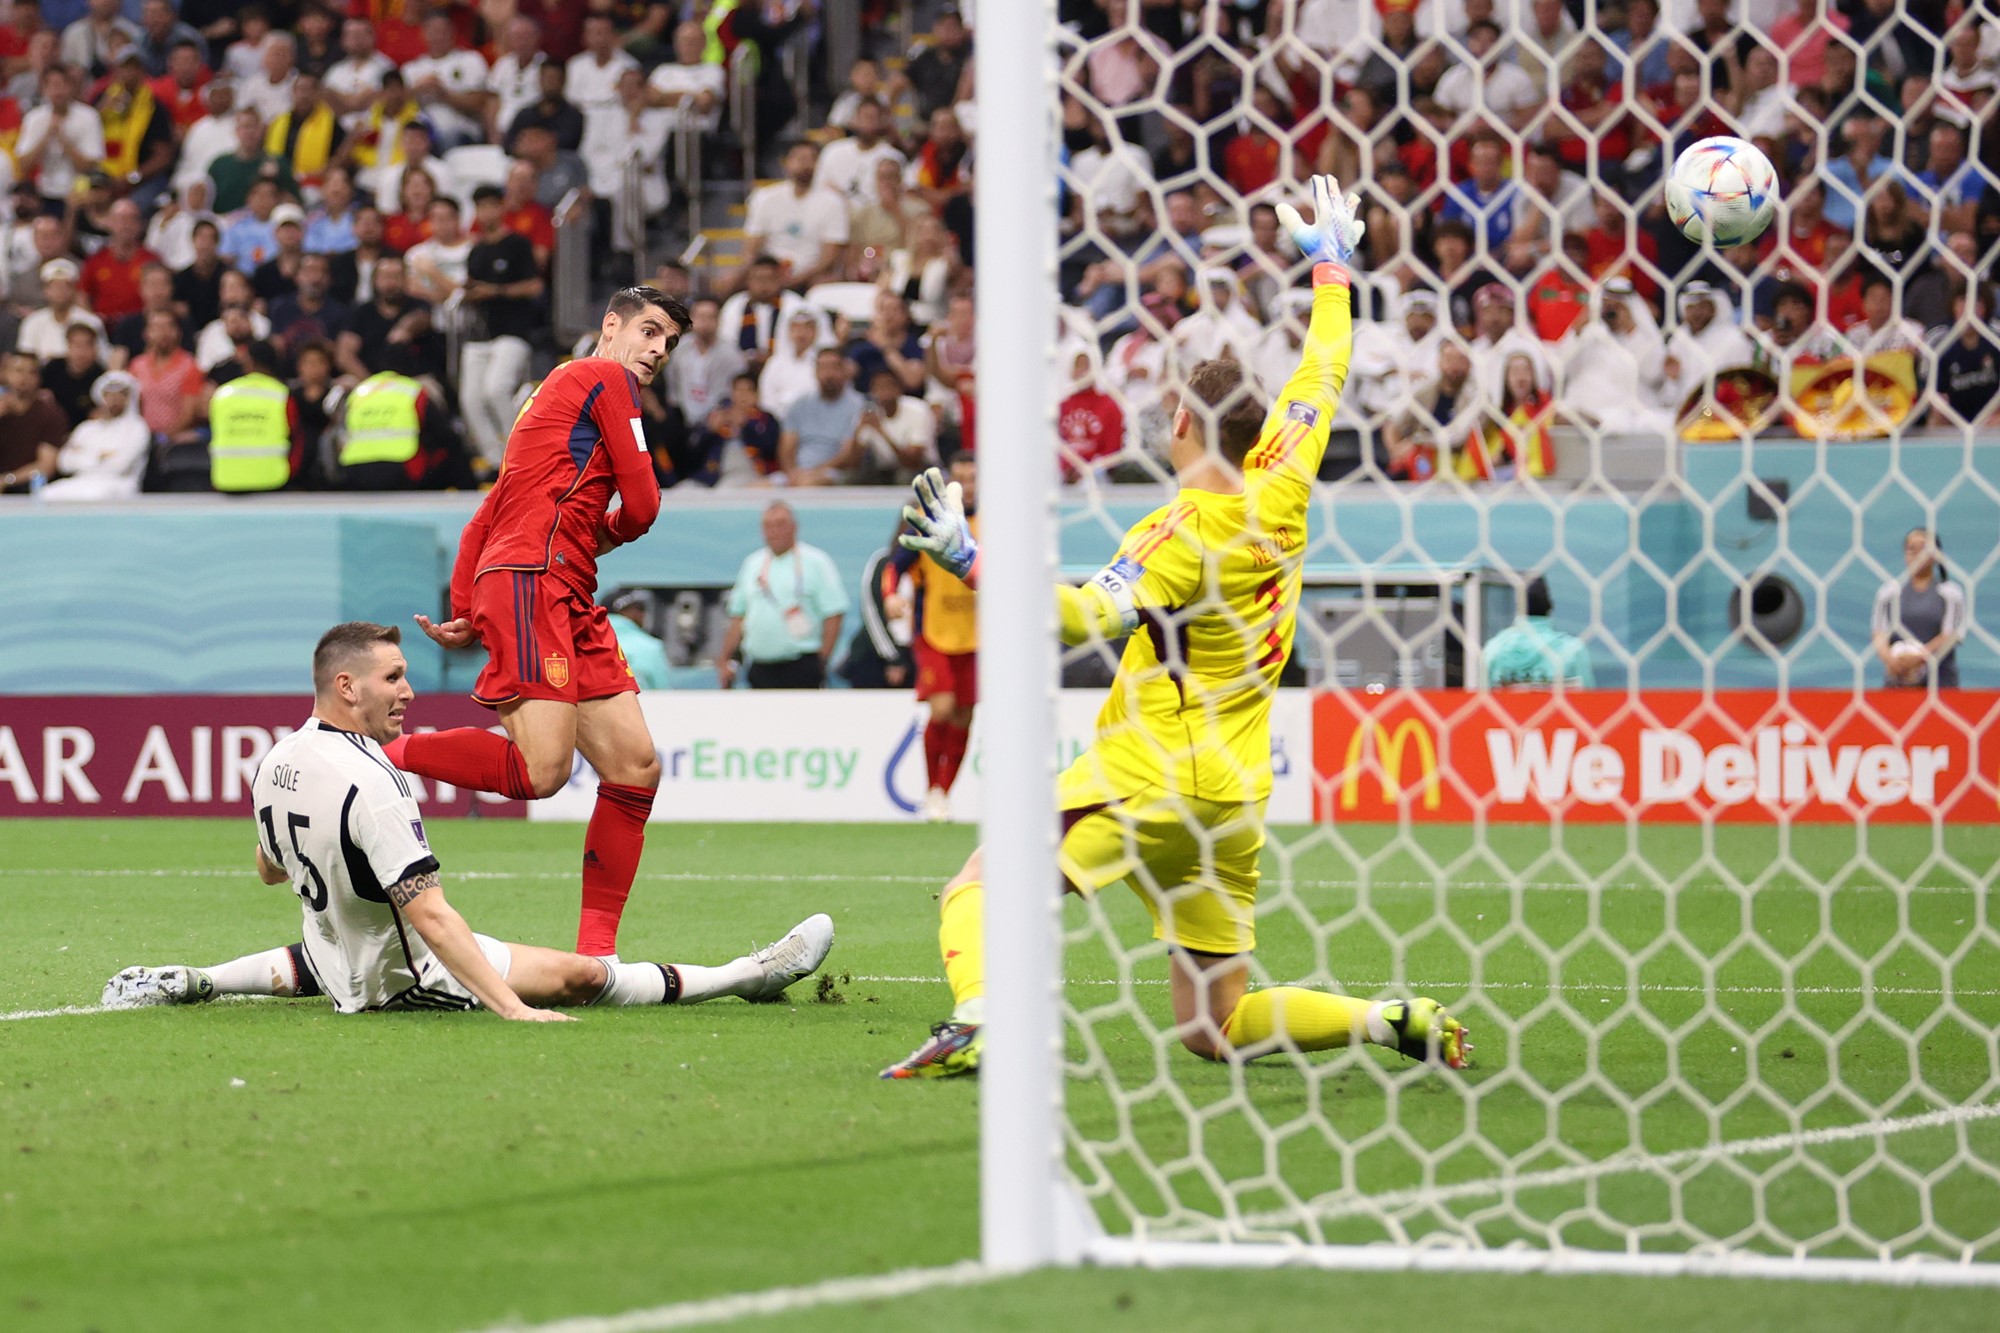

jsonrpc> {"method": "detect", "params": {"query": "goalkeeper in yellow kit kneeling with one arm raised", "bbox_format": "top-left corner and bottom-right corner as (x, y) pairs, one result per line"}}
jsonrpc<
(882, 176), (1470, 1079)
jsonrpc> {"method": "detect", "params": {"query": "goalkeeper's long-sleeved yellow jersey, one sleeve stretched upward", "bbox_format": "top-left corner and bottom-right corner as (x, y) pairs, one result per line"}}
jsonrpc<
(1062, 264), (1354, 809)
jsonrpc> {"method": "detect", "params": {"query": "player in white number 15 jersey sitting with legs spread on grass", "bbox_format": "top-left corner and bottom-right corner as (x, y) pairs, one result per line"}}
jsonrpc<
(104, 620), (834, 1023)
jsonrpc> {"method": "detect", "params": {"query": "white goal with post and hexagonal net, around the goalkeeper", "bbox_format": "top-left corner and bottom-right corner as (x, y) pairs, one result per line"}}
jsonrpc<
(978, 0), (2000, 1283)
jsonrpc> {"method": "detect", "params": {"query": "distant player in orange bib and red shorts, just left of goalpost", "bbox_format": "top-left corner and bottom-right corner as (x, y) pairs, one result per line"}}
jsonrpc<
(882, 452), (980, 823)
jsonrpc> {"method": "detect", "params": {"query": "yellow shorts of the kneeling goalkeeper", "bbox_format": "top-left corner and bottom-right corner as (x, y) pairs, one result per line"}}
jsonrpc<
(1056, 755), (1264, 953)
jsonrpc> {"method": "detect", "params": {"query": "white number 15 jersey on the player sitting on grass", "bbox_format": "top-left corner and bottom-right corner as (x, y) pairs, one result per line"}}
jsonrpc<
(250, 719), (452, 1013)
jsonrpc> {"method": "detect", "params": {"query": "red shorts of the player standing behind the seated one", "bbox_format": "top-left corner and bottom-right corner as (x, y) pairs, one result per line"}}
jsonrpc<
(472, 568), (638, 707)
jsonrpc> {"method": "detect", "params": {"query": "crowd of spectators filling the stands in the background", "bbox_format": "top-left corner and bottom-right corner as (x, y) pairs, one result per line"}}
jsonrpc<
(0, 0), (2000, 498)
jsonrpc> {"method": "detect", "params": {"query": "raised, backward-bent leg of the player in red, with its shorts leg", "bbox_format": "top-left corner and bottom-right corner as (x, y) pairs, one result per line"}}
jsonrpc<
(382, 570), (576, 801)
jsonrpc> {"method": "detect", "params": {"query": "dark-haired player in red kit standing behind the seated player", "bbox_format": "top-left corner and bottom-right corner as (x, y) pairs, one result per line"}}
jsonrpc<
(384, 286), (688, 957)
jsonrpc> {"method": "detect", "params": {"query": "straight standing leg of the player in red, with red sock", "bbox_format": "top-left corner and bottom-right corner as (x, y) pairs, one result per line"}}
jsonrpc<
(574, 606), (660, 955)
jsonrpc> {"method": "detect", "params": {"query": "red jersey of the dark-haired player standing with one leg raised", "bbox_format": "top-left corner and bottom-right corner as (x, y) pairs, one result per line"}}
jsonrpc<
(452, 356), (660, 616)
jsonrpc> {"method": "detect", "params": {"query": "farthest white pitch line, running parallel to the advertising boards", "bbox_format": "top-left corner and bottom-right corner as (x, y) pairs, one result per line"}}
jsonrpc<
(0, 867), (1996, 895)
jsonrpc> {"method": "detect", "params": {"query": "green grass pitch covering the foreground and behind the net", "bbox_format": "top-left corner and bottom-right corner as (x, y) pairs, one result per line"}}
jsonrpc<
(0, 821), (2000, 1333)
